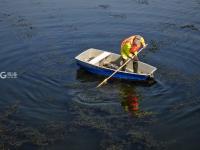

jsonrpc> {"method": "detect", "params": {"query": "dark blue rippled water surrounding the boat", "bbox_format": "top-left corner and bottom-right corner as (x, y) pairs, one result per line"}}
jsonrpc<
(0, 0), (200, 150)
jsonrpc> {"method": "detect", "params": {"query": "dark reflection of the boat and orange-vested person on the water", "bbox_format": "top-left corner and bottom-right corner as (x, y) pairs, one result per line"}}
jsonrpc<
(76, 69), (152, 118)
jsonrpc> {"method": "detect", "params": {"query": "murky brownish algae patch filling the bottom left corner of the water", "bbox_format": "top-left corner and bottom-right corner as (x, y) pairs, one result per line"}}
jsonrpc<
(0, 104), (68, 149)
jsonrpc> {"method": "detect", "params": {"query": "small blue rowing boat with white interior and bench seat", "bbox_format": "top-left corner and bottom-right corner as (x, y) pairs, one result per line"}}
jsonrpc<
(75, 48), (157, 81)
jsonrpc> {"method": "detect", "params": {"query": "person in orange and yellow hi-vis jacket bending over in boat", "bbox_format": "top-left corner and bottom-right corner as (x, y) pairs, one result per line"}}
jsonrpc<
(121, 35), (146, 73)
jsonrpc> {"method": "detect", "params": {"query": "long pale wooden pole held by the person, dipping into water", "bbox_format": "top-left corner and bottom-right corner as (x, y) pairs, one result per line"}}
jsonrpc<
(97, 44), (147, 88)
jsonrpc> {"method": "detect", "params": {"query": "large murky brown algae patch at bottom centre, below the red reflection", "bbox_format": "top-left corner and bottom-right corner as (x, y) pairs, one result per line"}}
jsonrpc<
(68, 100), (165, 150)
